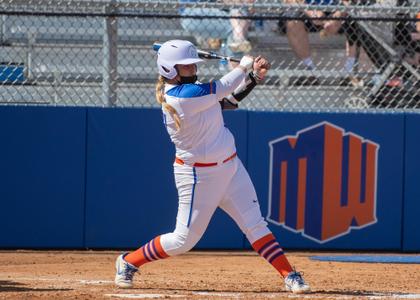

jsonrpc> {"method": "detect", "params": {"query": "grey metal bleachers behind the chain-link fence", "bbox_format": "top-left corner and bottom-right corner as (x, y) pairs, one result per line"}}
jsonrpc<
(0, 3), (418, 109)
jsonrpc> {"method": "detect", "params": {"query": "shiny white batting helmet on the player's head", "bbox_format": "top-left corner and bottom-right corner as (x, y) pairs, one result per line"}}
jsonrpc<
(157, 40), (203, 79)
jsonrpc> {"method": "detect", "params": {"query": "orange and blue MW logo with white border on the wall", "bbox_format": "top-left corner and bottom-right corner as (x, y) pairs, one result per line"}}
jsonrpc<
(267, 121), (379, 243)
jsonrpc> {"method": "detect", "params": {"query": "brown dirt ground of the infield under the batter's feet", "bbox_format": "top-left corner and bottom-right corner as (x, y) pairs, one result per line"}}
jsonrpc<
(0, 251), (420, 299)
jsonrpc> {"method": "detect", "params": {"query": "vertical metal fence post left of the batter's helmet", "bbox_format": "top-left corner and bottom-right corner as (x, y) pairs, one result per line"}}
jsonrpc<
(102, 0), (118, 106)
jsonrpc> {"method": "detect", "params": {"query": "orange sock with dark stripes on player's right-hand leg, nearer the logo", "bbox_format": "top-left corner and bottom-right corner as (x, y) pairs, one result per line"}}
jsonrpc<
(252, 233), (293, 277)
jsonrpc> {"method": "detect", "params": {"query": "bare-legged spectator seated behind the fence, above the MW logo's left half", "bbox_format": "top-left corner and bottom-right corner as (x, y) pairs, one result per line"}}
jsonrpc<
(279, 0), (356, 72)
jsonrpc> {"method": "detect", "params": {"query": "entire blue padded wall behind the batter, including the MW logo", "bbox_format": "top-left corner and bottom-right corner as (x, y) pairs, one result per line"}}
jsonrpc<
(0, 107), (420, 252)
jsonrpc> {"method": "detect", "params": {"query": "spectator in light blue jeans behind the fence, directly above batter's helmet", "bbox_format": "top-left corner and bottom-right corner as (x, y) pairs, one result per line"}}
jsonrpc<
(180, 0), (252, 54)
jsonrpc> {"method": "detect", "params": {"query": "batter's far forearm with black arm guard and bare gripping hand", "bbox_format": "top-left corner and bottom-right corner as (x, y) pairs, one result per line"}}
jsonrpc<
(219, 56), (270, 110)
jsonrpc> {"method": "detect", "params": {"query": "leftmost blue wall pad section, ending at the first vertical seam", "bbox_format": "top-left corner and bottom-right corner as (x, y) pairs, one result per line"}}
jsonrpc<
(0, 106), (86, 248)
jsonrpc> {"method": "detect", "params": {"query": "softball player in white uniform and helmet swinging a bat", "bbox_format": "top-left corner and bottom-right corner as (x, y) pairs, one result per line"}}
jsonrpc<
(115, 40), (310, 293)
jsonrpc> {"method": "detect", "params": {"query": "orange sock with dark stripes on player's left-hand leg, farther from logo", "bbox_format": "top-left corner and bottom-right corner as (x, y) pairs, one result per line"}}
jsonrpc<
(124, 236), (169, 268)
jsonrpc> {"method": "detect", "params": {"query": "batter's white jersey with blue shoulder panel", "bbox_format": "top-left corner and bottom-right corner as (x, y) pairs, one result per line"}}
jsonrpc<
(163, 68), (246, 165)
